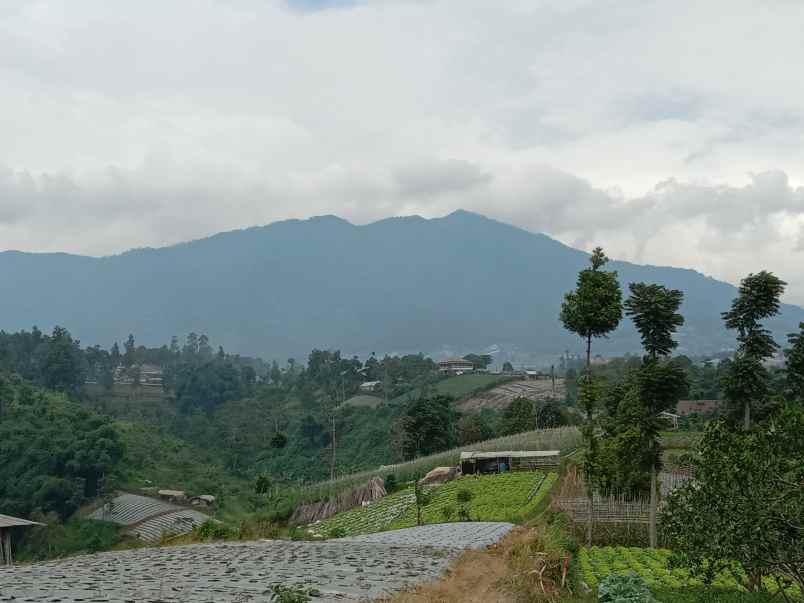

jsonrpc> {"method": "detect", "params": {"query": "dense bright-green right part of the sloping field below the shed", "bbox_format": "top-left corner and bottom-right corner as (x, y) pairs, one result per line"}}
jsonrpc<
(390, 471), (557, 529)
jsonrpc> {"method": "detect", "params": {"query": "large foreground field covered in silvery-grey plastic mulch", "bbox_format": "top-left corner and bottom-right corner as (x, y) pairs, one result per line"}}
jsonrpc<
(0, 523), (513, 603)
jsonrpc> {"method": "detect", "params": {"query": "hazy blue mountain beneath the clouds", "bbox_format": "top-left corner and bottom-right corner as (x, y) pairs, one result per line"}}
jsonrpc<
(0, 211), (804, 359)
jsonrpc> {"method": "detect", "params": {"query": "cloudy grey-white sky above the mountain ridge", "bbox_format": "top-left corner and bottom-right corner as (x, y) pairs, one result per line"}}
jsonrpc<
(0, 0), (804, 304)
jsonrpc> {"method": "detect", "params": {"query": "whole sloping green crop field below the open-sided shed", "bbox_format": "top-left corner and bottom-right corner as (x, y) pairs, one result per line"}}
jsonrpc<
(308, 472), (557, 538)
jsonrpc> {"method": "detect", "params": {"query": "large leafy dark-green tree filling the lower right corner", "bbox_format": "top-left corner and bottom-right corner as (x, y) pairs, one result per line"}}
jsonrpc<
(662, 405), (804, 592)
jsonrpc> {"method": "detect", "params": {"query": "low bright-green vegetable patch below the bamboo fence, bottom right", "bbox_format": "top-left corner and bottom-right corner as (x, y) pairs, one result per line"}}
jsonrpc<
(578, 546), (797, 592)
